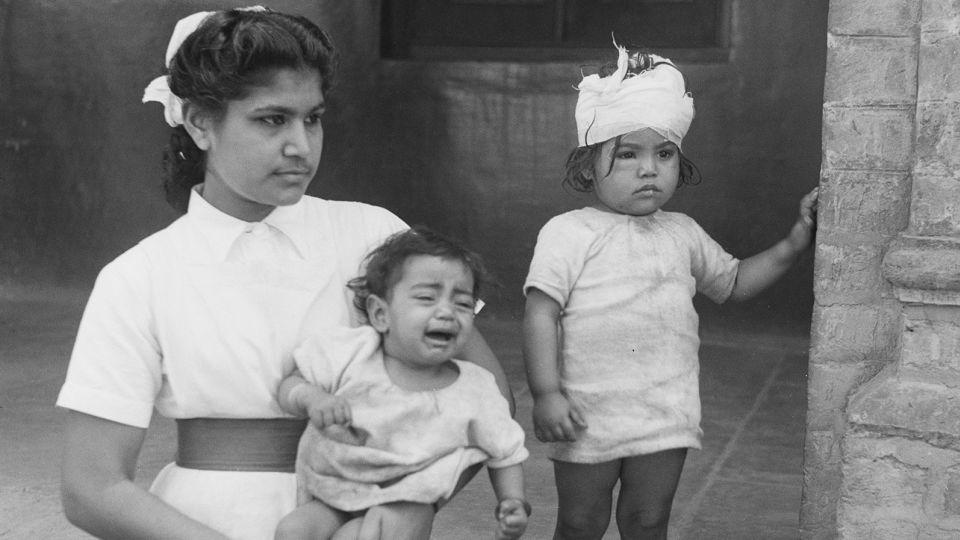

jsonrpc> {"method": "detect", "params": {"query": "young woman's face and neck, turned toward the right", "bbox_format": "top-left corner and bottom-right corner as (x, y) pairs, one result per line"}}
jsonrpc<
(194, 68), (324, 221)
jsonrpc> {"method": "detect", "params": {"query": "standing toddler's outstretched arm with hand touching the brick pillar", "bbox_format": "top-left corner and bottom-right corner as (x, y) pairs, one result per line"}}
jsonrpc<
(730, 188), (819, 301)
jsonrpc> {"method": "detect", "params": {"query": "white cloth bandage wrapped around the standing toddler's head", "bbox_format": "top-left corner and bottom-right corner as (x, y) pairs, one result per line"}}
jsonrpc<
(576, 46), (693, 148)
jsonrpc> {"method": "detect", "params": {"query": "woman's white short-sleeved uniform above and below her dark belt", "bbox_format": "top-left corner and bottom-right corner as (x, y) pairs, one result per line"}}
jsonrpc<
(57, 188), (406, 540)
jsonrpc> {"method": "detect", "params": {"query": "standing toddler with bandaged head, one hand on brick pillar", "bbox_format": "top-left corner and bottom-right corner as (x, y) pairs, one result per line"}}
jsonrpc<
(524, 47), (817, 539)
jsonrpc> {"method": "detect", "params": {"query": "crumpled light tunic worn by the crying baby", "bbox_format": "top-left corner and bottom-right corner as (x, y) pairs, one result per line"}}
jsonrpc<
(294, 326), (529, 511)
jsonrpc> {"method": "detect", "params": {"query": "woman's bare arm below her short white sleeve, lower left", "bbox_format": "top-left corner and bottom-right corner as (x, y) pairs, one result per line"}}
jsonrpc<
(61, 411), (226, 540)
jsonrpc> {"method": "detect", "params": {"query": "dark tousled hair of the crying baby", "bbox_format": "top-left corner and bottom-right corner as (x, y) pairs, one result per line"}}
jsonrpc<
(347, 226), (493, 317)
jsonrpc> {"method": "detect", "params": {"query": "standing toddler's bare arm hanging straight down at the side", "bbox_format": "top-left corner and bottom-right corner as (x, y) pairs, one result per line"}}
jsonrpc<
(523, 288), (587, 442)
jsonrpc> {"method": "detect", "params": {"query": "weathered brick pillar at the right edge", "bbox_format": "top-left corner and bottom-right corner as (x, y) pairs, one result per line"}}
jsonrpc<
(801, 0), (960, 539)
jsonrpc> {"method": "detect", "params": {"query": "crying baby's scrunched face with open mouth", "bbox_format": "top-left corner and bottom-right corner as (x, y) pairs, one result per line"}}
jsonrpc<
(383, 255), (475, 367)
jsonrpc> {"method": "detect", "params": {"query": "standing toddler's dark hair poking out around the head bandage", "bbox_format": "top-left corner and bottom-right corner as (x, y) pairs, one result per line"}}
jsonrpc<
(563, 44), (703, 192)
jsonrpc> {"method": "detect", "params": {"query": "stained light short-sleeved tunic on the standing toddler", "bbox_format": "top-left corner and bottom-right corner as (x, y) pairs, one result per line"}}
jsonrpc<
(524, 208), (739, 463)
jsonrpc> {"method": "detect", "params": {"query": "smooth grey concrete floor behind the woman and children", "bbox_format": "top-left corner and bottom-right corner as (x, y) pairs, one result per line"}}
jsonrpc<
(0, 291), (807, 540)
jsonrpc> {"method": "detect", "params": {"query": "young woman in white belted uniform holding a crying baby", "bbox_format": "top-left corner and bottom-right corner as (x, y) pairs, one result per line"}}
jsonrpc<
(57, 8), (509, 540)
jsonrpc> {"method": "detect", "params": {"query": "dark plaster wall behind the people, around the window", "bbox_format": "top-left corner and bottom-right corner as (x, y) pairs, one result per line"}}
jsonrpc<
(0, 0), (827, 324)
